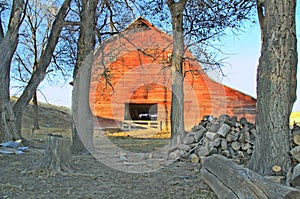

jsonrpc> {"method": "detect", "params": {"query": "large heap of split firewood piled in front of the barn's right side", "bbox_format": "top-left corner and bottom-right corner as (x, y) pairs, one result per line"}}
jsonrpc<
(183, 114), (255, 164)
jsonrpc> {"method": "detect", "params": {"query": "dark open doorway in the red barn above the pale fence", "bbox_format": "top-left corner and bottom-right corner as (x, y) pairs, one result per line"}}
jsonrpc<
(124, 103), (157, 121)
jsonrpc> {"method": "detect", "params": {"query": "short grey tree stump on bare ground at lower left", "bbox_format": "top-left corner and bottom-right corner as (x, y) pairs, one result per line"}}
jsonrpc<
(39, 135), (72, 173)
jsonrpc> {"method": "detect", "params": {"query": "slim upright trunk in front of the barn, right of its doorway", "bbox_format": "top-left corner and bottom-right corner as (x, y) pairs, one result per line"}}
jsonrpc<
(167, 0), (186, 145)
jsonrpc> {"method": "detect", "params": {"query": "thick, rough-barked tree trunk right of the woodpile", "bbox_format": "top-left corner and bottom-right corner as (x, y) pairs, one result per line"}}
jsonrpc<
(248, 0), (297, 175)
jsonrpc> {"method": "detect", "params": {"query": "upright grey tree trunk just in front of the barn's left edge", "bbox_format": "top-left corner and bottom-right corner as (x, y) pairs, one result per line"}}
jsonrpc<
(72, 0), (97, 153)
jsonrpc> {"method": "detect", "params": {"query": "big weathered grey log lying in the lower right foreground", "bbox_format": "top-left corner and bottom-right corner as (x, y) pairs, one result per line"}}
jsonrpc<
(200, 155), (300, 199)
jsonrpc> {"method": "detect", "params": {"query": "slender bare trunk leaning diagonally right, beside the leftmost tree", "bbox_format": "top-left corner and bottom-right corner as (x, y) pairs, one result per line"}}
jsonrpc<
(13, 0), (71, 134)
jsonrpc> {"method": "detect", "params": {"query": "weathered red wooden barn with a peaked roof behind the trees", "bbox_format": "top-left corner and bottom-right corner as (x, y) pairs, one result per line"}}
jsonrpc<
(90, 17), (256, 130)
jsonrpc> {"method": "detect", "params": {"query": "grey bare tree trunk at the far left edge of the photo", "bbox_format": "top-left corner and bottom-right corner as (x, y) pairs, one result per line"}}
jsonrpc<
(0, 0), (24, 141)
